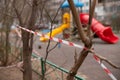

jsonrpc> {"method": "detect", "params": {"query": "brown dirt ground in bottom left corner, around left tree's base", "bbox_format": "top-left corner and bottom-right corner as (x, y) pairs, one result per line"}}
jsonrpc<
(0, 67), (39, 80)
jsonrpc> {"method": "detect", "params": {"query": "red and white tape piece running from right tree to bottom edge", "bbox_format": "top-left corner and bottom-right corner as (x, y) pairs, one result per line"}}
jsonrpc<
(94, 55), (117, 80)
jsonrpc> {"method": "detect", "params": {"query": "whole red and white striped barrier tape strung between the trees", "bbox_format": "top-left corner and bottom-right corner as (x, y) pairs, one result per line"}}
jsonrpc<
(17, 26), (117, 80)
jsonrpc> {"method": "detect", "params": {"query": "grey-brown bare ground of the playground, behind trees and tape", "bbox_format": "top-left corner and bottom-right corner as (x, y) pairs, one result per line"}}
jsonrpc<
(0, 34), (120, 80)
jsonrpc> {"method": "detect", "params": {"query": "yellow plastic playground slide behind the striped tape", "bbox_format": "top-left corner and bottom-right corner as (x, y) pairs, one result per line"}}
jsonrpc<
(40, 13), (70, 42)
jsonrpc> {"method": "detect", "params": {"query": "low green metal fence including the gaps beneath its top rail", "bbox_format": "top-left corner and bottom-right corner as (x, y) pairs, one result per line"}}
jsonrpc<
(32, 53), (85, 80)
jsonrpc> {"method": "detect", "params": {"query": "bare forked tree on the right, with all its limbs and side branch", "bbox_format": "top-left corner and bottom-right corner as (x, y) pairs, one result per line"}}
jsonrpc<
(67, 0), (120, 80)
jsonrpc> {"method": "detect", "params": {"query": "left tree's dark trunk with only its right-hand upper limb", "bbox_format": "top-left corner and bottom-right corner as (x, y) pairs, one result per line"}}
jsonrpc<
(21, 0), (38, 80)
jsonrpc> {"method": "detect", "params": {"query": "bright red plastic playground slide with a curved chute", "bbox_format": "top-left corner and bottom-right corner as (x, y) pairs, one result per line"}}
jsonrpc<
(80, 13), (119, 44)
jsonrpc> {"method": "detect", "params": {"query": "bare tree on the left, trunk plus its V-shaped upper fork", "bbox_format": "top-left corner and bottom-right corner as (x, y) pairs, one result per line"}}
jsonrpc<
(13, 0), (39, 80)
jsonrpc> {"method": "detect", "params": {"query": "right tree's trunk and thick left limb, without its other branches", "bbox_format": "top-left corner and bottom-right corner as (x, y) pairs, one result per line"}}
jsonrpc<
(67, 0), (92, 80)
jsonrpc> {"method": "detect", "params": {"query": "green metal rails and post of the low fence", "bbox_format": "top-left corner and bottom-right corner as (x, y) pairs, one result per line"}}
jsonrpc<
(32, 53), (85, 80)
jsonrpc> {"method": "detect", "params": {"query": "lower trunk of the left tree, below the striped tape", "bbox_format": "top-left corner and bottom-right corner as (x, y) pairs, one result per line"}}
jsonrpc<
(22, 31), (32, 80)
